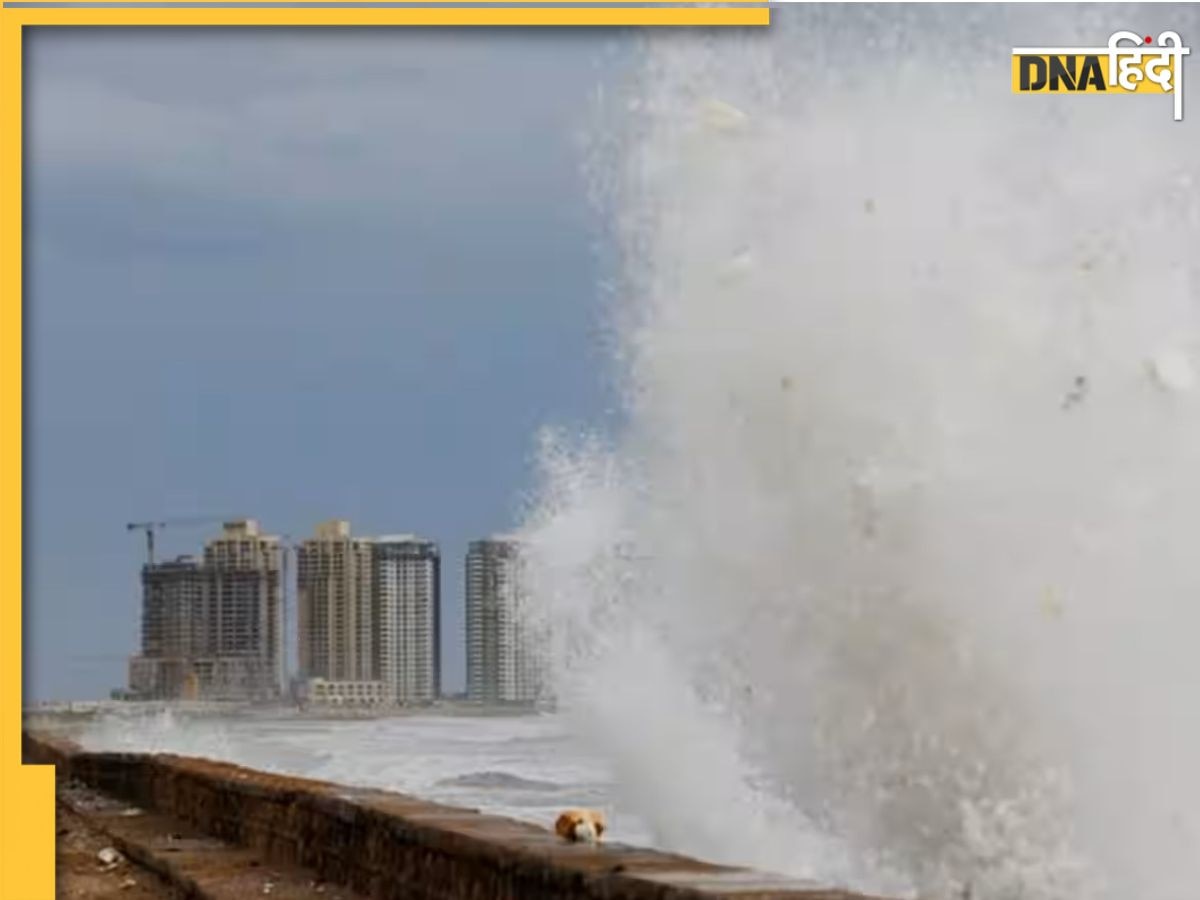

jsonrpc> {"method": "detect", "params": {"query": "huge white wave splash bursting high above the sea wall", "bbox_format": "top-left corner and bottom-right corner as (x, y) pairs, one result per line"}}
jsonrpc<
(526, 6), (1200, 900)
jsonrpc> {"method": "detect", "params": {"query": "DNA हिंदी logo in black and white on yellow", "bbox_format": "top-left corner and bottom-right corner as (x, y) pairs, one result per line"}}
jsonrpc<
(1013, 31), (1190, 121)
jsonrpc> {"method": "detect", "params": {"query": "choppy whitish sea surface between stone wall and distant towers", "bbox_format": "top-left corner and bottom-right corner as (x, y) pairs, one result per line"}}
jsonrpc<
(78, 709), (656, 846)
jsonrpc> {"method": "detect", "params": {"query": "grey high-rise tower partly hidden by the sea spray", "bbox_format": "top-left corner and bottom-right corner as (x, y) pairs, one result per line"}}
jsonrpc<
(467, 535), (546, 703)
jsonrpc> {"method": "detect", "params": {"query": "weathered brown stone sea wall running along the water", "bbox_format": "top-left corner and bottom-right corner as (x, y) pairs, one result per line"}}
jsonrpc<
(23, 732), (878, 900)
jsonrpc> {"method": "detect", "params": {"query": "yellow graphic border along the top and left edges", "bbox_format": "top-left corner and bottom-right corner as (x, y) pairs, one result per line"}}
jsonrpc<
(0, 0), (770, 900)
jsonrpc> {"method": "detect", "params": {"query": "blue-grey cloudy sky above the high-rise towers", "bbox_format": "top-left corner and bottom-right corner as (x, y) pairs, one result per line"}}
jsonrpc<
(24, 29), (629, 701)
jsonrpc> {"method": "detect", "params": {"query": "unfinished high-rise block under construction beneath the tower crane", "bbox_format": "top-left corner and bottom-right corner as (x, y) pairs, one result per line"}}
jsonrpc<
(130, 520), (283, 700)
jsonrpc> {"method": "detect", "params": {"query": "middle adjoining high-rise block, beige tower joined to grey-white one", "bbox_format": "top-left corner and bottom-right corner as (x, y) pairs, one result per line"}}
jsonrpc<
(296, 520), (440, 703)
